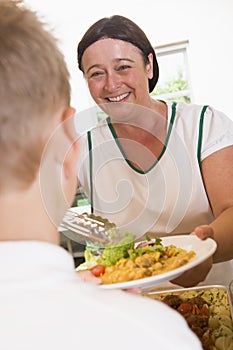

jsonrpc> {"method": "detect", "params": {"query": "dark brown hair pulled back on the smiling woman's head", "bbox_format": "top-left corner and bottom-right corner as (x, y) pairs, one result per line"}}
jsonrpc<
(78, 15), (159, 92)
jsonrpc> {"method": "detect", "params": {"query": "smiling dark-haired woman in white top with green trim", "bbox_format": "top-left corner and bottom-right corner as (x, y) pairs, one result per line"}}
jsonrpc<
(75, 15), (233, 287)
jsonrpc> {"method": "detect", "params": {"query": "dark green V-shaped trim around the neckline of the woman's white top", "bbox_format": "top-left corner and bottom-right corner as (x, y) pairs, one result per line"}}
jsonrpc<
(106, 102), (177, 174)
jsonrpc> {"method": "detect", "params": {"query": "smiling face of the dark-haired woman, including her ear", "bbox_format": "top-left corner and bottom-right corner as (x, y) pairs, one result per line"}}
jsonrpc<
(82, 38), (153, 118)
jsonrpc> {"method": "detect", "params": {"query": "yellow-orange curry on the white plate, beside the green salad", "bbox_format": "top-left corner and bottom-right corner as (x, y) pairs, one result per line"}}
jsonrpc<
(101, 245), (196, 284)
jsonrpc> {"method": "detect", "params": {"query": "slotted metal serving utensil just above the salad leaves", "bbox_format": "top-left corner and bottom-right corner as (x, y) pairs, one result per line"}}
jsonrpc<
(60, 210), (120, 247)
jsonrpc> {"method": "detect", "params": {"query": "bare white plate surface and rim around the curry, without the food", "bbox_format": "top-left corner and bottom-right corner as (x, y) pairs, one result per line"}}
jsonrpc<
(100, 235), (217, 290)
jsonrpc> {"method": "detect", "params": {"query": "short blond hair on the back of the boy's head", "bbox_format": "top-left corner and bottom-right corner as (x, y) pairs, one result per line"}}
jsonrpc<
(0, 0), (70, 192)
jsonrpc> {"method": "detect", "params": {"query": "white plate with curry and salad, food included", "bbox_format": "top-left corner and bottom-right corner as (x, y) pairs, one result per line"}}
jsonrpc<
(77, 233), (217, 290)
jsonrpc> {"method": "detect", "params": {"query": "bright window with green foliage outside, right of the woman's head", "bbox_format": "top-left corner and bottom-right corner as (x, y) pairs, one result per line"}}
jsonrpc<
(151, 41), (192, 103)
